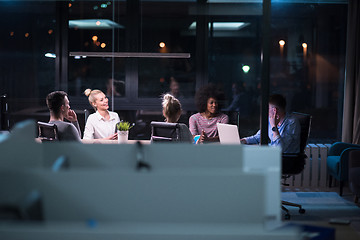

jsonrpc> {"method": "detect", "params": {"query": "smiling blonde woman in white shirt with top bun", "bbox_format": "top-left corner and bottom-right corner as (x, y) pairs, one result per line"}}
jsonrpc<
(83, 89), (120, 140)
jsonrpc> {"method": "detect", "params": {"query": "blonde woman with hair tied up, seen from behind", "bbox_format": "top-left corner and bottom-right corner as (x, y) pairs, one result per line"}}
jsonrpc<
(162, 94), (193, 143)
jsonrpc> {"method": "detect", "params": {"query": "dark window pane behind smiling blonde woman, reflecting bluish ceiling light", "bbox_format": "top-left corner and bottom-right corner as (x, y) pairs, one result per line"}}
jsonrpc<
(68, 1), (126, 101)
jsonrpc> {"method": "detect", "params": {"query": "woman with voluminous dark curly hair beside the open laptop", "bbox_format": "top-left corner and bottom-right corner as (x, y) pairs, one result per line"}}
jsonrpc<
(189, 84), (229, 143)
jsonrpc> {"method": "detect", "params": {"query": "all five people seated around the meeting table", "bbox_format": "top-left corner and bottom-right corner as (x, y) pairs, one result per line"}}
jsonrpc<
(46, 84), (300, 153)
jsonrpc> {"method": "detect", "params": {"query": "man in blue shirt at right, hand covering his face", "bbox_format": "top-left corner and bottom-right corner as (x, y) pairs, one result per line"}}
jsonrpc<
(240, 94), (300, 153)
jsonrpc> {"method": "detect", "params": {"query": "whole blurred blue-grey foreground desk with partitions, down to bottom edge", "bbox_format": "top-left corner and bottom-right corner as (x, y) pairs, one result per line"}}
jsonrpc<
(0, 122), (300, 240)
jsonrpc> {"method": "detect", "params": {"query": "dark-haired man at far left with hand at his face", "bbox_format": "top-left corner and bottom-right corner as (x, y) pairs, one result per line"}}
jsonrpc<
(46, 91), (81, 142)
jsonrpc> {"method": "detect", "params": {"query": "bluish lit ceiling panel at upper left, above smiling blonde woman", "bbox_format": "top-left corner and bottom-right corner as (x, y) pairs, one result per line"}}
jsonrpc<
(69, 19), (124, 29)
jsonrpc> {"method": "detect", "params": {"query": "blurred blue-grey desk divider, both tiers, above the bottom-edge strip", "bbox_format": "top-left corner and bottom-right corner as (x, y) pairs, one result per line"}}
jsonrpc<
(0, 120), (281, 234)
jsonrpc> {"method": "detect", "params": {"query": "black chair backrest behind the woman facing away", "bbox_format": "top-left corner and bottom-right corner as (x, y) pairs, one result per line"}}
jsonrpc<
(151, 122), (180, 142)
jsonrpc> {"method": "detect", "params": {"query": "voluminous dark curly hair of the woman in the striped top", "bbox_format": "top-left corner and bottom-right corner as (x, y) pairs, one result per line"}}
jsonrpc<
(195, 83), (225, 112)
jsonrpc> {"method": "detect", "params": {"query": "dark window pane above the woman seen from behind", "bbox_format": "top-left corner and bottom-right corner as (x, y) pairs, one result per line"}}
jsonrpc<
(138, 1), (196, 98)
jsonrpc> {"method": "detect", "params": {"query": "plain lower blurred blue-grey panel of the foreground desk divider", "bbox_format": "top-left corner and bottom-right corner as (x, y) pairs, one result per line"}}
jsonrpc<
(1, 169), (266, 224)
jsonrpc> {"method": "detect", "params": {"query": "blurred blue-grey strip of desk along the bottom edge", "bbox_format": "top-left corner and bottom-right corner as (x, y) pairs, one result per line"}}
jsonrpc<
(0, 222), (301, 240)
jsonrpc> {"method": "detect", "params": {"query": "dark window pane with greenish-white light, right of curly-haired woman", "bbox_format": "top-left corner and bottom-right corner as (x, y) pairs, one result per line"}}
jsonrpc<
(208, 16), (261, 136)
